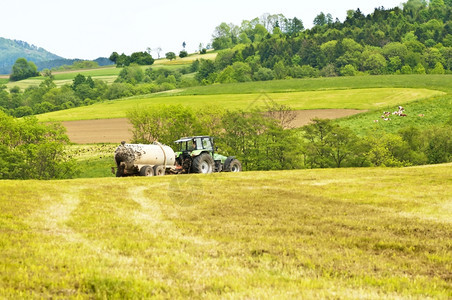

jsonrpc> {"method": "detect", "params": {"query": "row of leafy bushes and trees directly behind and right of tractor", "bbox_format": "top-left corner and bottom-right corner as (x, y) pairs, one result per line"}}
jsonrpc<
(128, 103), (452, 171)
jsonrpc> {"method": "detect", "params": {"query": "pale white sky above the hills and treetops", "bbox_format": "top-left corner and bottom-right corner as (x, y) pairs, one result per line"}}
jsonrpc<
(0, 0), (406, 59)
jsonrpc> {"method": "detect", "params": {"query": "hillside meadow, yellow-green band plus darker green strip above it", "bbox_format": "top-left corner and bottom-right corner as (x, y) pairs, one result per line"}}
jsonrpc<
(39, 75), (452, 121)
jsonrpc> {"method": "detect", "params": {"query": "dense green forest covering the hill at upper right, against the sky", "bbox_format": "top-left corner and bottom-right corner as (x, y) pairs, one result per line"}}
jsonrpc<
(197, 0), (452, 84)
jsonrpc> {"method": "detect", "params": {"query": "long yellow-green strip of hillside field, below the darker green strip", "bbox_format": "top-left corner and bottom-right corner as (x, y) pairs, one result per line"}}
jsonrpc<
(38, 88), (443, 121)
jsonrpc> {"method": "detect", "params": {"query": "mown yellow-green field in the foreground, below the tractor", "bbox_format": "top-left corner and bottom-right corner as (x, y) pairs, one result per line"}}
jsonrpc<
(0, 164), (452, 299)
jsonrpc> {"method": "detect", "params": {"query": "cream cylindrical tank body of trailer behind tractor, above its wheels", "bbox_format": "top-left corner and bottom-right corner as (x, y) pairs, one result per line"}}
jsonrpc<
(115, 143), (176, 169)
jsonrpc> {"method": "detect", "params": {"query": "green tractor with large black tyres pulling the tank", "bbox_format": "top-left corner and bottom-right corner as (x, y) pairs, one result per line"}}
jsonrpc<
(175, 136), (242, 174)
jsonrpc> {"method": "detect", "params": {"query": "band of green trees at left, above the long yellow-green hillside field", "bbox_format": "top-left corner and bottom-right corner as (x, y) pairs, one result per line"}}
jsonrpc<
(0, 64), (197, 118)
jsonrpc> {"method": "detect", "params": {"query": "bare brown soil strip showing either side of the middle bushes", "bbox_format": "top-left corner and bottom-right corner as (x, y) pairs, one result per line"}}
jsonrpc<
(63, 109), (364, 144)
